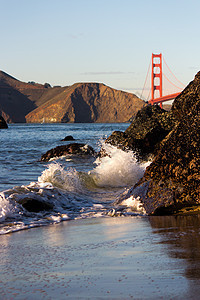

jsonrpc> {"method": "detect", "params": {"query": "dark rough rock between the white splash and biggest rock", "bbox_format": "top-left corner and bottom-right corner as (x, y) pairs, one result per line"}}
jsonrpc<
(106, 105), (176, 157)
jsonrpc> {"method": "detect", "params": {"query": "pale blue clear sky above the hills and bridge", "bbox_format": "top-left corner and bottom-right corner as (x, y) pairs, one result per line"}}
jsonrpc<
(0, 0), (200, 99)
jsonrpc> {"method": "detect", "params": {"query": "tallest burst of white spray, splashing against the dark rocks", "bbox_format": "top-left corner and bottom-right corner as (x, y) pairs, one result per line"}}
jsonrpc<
(89, 144), (148, 187)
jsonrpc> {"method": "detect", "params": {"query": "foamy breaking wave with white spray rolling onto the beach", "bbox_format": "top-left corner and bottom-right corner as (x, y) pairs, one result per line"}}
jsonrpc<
(0, 144), (148, 234)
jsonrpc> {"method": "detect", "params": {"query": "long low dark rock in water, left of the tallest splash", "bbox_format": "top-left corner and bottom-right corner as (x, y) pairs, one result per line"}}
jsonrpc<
(41, 143), (95, 161)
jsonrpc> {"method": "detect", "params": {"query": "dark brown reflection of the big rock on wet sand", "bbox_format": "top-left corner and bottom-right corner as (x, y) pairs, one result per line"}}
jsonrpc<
(149, 215), (200, 280)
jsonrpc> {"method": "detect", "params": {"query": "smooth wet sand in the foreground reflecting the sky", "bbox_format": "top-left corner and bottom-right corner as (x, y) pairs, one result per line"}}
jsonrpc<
(0, 217), (200, 300)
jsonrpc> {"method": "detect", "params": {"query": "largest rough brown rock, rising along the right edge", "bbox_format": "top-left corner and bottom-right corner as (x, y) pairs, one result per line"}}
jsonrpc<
(125, 72), (200, 214)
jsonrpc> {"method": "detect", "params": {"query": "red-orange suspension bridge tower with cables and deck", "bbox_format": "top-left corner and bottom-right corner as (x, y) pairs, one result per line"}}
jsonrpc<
(141, 53), (185, 107)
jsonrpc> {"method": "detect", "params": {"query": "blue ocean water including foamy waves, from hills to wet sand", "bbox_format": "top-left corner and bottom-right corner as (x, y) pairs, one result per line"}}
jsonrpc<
(0, 123), (148, 234)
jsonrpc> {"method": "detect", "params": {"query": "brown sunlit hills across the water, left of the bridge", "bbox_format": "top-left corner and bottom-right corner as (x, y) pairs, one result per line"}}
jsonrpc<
(0, 71), (145, 123)
